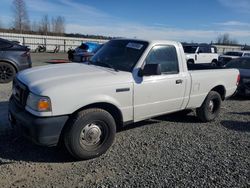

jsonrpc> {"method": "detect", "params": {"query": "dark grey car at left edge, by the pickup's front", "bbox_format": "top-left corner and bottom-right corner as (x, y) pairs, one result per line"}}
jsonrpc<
(0, 38), (31, 83)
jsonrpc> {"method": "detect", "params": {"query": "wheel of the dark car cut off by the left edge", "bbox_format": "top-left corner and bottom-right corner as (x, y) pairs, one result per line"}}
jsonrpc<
(0, 62), (16, 83)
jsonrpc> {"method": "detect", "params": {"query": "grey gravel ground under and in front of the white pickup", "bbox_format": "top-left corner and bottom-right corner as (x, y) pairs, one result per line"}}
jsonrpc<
(0, 53), (250, 187)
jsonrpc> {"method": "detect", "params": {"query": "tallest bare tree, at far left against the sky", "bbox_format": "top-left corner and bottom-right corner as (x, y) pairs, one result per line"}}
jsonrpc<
(13, 0), (30, 33)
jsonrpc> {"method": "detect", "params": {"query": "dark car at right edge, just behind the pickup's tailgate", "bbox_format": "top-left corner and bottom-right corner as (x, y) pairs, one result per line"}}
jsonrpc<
(225, 57), (250, 96)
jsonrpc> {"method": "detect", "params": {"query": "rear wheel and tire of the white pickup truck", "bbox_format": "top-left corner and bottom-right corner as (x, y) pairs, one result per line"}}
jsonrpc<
(196, 91), (221, 122)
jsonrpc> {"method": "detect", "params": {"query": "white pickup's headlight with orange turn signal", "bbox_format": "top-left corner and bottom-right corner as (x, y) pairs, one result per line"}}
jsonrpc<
(27, 93), (51, 112)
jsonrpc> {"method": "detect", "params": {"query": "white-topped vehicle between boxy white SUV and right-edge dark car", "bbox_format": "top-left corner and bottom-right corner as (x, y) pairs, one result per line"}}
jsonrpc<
(218, 51), (250, 66)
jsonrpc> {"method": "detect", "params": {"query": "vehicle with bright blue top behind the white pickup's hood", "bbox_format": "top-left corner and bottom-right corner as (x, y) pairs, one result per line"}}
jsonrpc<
(68, 42), (102, 62)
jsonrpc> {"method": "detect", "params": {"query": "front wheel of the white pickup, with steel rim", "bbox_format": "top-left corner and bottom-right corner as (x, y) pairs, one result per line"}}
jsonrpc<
(64, 108), (116, 160)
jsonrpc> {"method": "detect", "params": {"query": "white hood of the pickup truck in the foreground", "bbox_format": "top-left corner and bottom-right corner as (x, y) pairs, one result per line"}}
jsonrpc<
(17, 63), (132, 95)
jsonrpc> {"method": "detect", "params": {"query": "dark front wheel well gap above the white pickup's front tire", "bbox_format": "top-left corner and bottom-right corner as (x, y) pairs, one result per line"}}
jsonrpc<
(73, 102), (123, 127)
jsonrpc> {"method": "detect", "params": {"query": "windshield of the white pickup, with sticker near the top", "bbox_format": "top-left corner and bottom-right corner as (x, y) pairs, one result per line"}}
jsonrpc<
(90, 40), (148, 72)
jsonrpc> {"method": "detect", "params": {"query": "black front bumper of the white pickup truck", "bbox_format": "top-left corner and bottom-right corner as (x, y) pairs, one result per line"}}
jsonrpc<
(9, 97), (68, 146)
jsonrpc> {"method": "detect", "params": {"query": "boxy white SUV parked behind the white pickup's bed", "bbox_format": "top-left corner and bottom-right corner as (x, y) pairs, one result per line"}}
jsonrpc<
(182, 43), (218, 66)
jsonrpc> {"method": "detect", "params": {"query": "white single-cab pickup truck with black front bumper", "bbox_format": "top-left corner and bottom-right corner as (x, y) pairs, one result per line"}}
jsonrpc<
(9, 39), (239, 159)
